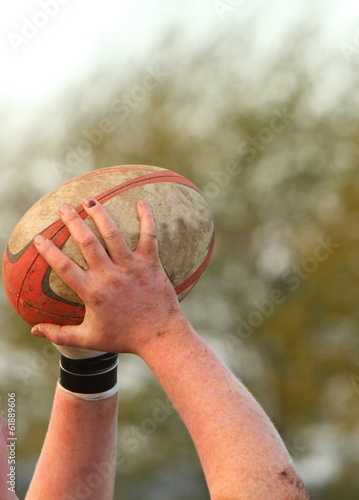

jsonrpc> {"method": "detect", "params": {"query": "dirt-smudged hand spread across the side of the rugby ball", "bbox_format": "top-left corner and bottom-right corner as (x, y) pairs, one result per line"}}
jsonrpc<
(31, 199), (184, 355)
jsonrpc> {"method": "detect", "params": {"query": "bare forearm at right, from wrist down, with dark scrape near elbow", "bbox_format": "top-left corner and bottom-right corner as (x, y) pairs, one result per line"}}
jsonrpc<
(142, 320), (307, 500)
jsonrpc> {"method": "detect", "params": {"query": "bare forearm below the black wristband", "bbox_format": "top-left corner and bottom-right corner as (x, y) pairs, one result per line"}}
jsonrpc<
(26, 387), (118, 500)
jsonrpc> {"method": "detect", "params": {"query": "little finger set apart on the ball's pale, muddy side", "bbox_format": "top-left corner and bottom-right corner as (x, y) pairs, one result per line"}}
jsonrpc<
(136, 200), (159, 260)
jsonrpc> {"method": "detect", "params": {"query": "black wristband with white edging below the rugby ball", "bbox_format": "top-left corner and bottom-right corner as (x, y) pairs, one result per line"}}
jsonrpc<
(60, 353), (118, 394)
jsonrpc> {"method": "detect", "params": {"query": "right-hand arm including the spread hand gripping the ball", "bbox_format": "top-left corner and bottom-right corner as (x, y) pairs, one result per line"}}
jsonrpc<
(33, 202), (307, 500)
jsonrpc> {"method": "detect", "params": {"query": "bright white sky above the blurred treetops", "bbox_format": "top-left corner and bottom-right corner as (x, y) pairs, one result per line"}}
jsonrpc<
(0, 0), (359, 107)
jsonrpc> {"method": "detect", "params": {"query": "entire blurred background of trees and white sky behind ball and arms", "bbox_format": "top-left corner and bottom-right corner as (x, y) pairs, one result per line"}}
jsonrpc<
(0, 0), (359, 500)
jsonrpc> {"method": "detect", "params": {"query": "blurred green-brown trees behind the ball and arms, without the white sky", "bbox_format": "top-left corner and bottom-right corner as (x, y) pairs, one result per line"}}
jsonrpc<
(0, 4), (359, 500)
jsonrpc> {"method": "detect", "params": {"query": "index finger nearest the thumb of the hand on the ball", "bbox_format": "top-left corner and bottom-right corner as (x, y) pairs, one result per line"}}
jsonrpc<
(34, 234), (86, 295)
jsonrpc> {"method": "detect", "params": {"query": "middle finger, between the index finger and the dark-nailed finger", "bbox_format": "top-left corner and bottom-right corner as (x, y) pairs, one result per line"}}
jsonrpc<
(60, 205), (108, 268)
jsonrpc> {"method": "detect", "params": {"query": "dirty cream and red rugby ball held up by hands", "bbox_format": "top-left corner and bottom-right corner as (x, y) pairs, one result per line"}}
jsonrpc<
(3, 165), (214, 325)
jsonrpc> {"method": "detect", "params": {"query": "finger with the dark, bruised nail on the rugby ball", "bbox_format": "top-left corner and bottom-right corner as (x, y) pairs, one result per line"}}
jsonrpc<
(83, 198), (131, 263)
